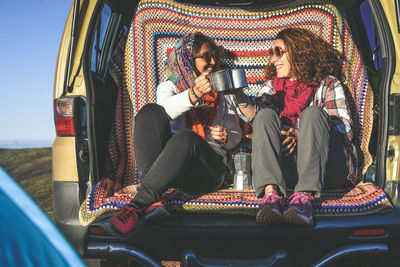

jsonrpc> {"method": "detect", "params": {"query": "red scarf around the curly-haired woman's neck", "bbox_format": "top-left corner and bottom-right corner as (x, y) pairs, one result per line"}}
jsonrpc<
(273, 76), (317, 127)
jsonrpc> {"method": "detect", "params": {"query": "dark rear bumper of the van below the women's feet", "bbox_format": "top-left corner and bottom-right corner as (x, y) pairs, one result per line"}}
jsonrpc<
(87, 209), (400, 266)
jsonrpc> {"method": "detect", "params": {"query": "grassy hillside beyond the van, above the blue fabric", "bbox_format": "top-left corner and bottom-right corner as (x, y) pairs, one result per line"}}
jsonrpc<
(0, 148), (54, 219)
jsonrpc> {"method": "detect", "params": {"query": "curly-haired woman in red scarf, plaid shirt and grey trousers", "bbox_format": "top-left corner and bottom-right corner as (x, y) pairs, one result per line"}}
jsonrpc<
(236, 28), (357, 225)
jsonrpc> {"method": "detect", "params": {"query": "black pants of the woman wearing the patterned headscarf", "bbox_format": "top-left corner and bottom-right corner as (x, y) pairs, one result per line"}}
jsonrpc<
(131, 104), (225, 208)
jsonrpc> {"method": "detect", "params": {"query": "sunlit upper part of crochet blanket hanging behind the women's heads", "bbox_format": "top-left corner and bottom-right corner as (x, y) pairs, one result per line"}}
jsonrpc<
(124, 0), (373, 177)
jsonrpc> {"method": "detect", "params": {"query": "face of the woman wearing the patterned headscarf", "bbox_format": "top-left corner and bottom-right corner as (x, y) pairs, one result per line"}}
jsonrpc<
(194, 43), (219, 75)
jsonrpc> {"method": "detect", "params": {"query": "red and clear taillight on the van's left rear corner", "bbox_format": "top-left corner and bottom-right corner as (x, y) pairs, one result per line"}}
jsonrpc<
(54, 98), (75, 136)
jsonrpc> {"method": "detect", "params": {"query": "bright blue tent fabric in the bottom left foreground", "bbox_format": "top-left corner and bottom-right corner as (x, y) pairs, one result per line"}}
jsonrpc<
(0, 167), (85, 266)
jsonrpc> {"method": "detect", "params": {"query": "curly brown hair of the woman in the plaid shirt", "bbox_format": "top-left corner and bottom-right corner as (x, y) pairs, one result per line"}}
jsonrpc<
(264, 28), (341, 86)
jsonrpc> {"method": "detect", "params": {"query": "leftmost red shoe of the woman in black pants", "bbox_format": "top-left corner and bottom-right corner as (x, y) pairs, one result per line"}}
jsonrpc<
(99, 205), (140, 237)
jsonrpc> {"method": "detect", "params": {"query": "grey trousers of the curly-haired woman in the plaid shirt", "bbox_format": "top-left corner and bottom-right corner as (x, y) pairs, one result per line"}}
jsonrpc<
(252, 107), (348, 197)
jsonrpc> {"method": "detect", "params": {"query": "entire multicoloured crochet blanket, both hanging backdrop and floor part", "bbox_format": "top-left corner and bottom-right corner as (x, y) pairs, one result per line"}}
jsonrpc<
(80, 0), (382, 225)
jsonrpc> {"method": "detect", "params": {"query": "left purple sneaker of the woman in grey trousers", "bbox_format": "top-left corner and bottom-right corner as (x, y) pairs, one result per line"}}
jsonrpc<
(256, 190), (285, 224)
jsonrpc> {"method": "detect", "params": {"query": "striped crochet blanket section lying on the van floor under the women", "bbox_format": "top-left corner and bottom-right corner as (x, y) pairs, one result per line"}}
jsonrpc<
(79, 180), (392, 226)
